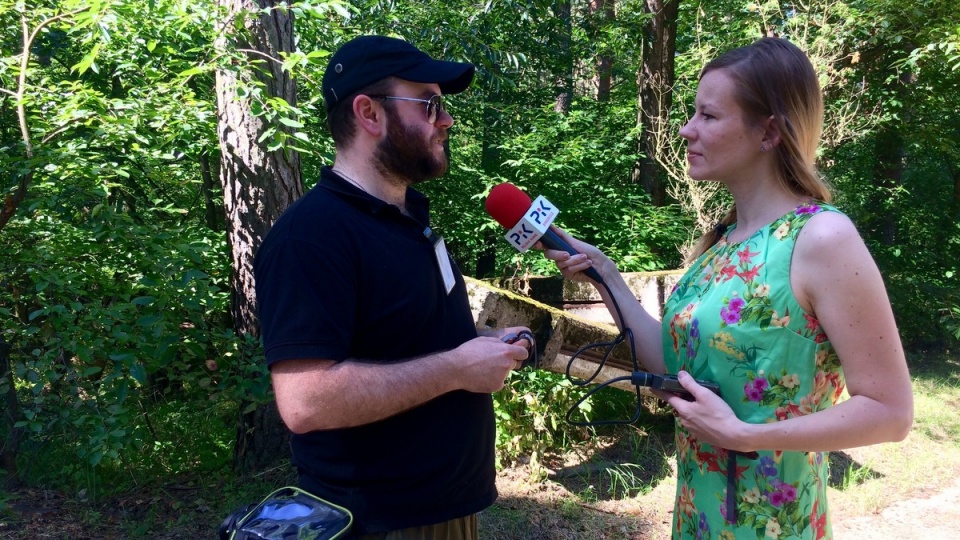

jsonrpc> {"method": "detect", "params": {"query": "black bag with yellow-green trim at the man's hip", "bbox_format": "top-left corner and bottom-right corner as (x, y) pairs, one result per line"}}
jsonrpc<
(220, 486), (353, 540)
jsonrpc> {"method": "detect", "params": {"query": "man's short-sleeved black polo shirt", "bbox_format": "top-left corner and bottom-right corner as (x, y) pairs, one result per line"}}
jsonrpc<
(254, 167), (497, 533)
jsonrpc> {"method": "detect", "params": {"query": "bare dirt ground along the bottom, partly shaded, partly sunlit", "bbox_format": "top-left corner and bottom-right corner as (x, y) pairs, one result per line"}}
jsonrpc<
(0, 442), (960, 540)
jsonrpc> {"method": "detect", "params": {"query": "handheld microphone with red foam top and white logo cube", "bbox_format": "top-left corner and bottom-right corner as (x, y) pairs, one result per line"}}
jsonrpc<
(486, 182), (603, 283)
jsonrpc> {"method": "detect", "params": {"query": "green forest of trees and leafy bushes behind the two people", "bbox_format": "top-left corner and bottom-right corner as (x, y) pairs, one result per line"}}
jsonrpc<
(0, 0), (960, 536)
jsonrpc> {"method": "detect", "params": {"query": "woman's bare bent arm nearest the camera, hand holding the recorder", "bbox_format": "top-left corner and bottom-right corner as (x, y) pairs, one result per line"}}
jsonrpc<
(669, 212), (913, 451)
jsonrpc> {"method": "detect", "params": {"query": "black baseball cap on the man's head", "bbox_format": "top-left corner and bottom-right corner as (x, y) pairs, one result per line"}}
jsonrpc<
(323, 36), (475, 111)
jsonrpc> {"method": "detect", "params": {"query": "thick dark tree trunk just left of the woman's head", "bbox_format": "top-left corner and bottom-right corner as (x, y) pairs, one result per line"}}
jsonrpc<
(633, 0), (680, 206)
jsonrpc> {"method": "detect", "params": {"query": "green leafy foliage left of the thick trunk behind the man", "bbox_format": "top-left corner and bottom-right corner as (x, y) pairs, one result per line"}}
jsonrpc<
(0, 2), (268, 492)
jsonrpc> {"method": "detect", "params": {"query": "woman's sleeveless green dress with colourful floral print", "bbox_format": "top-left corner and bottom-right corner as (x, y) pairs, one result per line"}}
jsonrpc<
(663, 203), (845, 539)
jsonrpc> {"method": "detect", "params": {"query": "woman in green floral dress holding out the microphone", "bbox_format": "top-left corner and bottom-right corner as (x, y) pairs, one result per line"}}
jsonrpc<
(545, 38), (913, 539)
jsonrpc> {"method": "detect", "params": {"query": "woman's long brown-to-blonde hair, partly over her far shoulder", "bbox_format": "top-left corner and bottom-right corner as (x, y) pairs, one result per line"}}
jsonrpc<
(688, 37), (833, 262)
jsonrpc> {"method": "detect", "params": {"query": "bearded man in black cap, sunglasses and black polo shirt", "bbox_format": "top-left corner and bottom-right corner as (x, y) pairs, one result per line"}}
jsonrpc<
(255, 36), (528, 540)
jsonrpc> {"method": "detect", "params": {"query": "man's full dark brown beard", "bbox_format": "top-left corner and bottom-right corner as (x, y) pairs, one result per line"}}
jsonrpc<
(373, 107), (450, 185)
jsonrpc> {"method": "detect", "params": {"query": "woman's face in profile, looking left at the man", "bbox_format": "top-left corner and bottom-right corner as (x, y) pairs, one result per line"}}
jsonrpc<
(680, 69), (764, 184)
